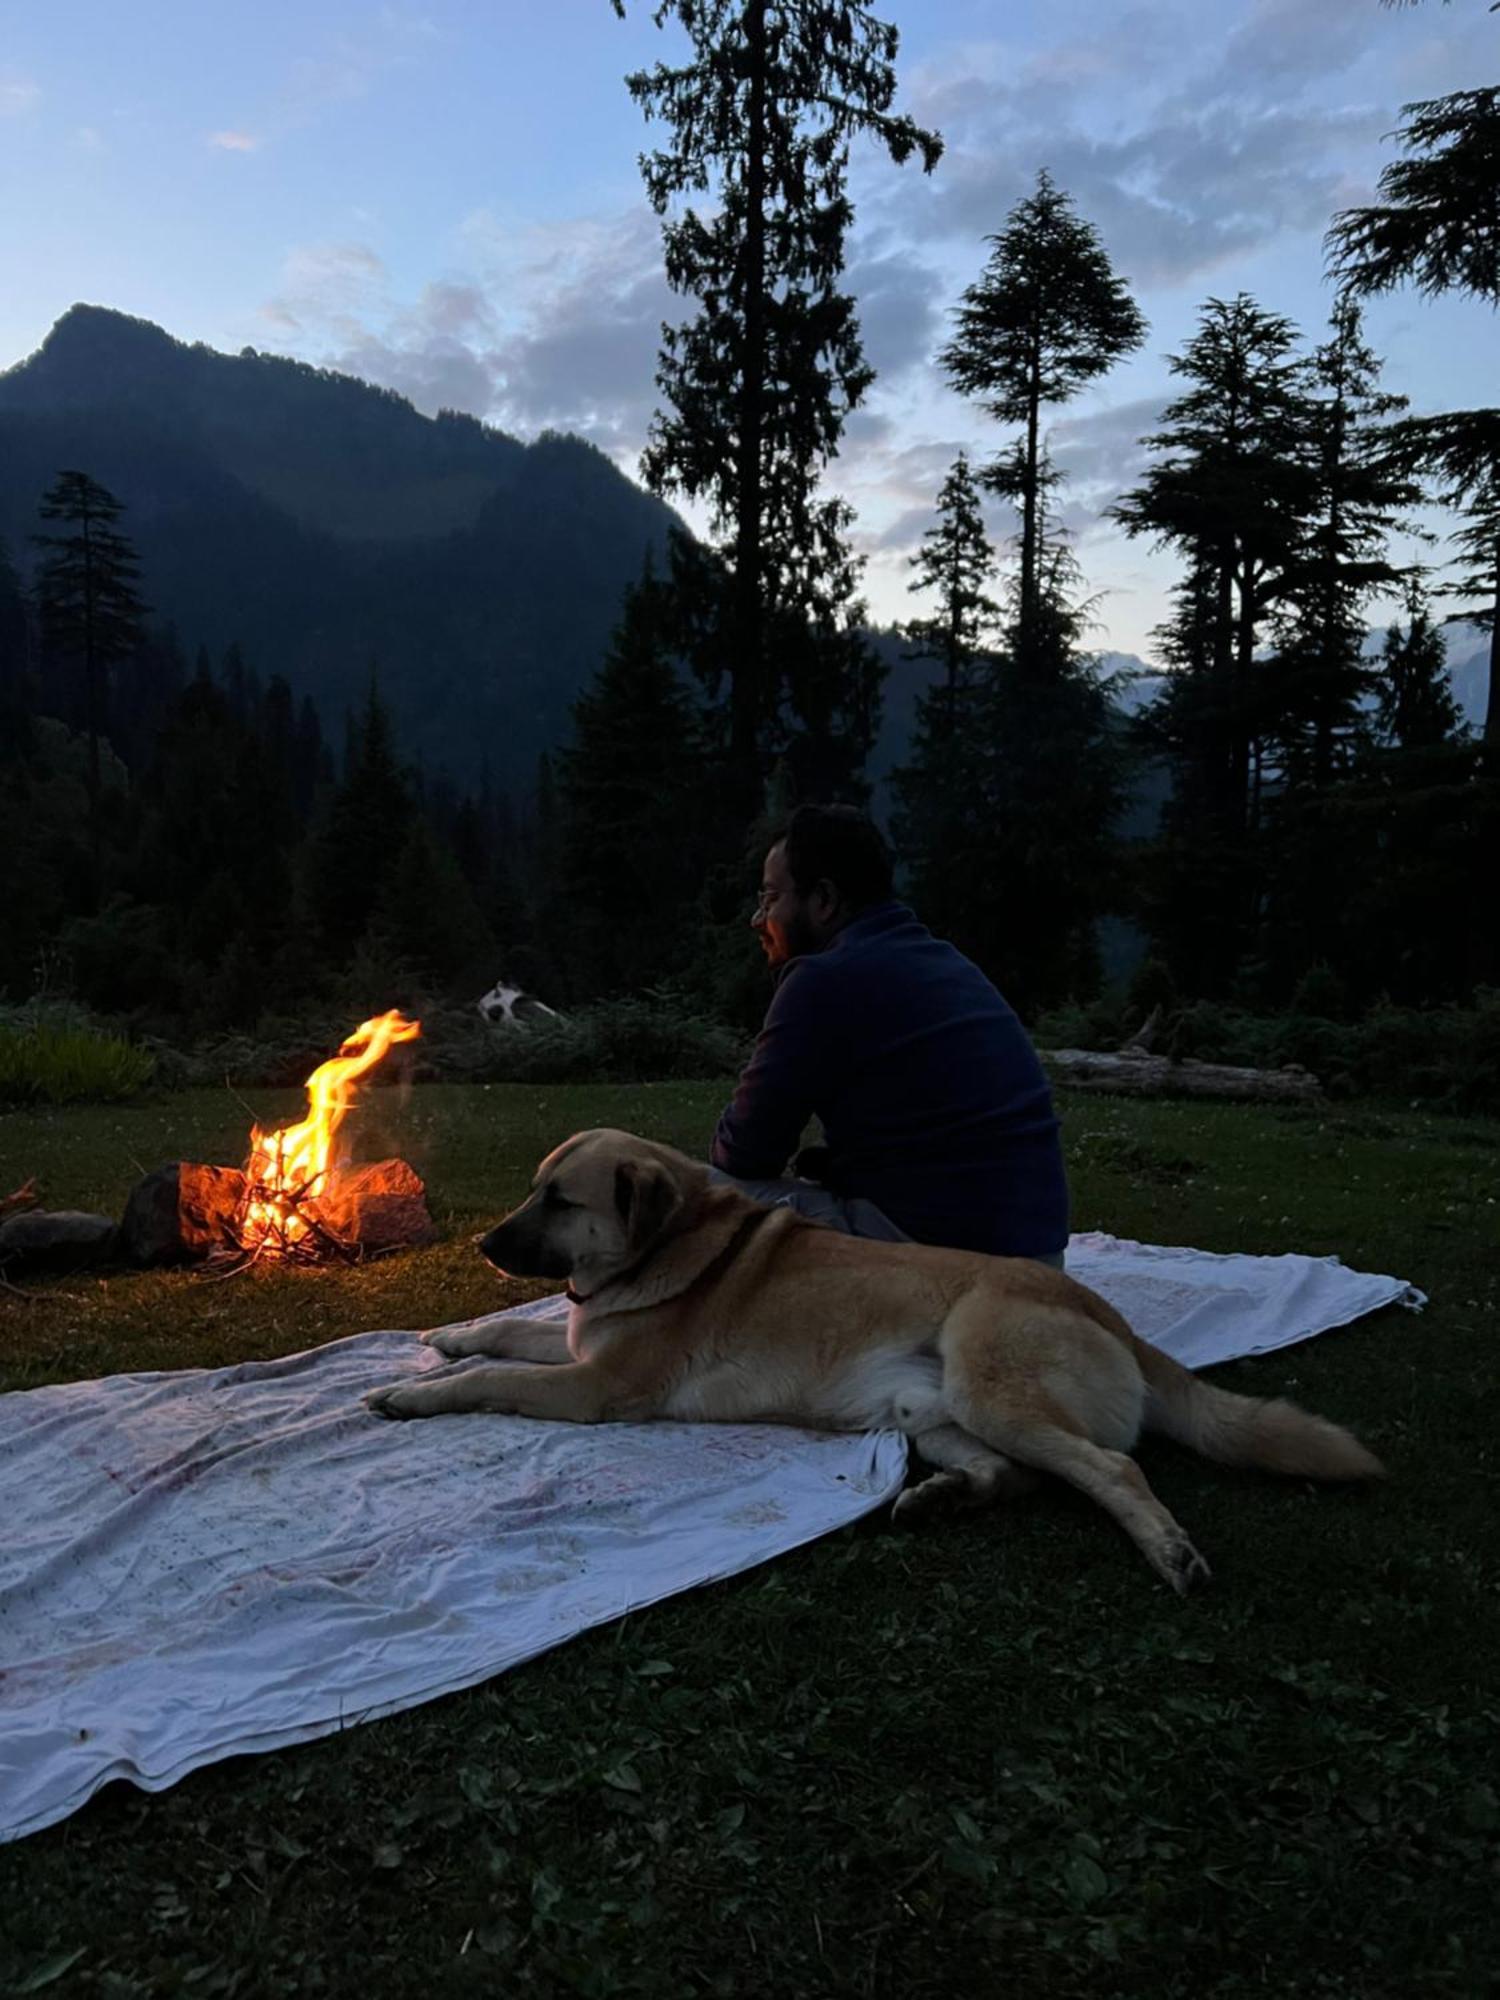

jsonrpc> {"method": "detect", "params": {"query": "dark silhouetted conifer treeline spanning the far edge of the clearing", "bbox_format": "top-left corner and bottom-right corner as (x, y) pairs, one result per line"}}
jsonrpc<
(0, 31), (1500, 1056)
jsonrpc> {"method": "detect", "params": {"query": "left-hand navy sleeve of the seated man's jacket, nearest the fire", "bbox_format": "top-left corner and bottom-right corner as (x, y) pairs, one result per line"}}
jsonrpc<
(708, 960), (836, 1180)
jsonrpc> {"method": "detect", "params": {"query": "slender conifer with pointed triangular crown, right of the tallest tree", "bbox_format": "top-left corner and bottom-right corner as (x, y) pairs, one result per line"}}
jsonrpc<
(942, 172), (1146, 648)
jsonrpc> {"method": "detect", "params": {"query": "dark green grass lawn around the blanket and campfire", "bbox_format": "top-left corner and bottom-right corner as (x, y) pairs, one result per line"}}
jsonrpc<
(0, 1084), (1500, 2000)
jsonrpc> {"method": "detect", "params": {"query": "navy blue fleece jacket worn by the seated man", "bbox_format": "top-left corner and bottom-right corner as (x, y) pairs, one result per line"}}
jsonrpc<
(712, 902), (1068, 1256)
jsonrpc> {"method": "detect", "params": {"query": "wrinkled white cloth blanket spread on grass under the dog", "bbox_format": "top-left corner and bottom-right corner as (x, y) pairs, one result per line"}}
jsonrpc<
(0, 1236), (1420, 1842)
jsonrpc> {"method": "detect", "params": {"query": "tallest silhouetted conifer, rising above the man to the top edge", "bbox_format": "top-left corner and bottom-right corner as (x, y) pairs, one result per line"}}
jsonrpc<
(616, 0), (940, 812)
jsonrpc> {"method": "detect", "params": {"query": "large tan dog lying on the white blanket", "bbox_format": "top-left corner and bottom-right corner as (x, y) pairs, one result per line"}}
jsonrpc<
(366, 1132), (1382, 1592)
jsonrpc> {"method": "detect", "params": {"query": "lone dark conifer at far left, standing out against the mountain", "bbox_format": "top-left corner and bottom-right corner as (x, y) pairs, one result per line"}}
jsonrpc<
(34, 472), (146, 896)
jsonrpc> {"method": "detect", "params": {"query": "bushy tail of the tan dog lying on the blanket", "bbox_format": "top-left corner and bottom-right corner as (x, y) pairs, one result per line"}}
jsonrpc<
(1130, 1334), (1386, 1480)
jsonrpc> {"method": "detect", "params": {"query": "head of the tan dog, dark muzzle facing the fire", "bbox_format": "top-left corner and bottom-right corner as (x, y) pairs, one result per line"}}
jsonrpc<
(480, 1130), (708, 1296)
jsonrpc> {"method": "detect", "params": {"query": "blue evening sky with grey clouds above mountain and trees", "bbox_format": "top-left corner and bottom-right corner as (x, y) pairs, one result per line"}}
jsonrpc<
(0, 0), (1500, 654)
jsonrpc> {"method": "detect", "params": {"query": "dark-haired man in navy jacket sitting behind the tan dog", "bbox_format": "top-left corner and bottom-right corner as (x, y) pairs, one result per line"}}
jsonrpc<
(710, 806), (1068, 1266)
